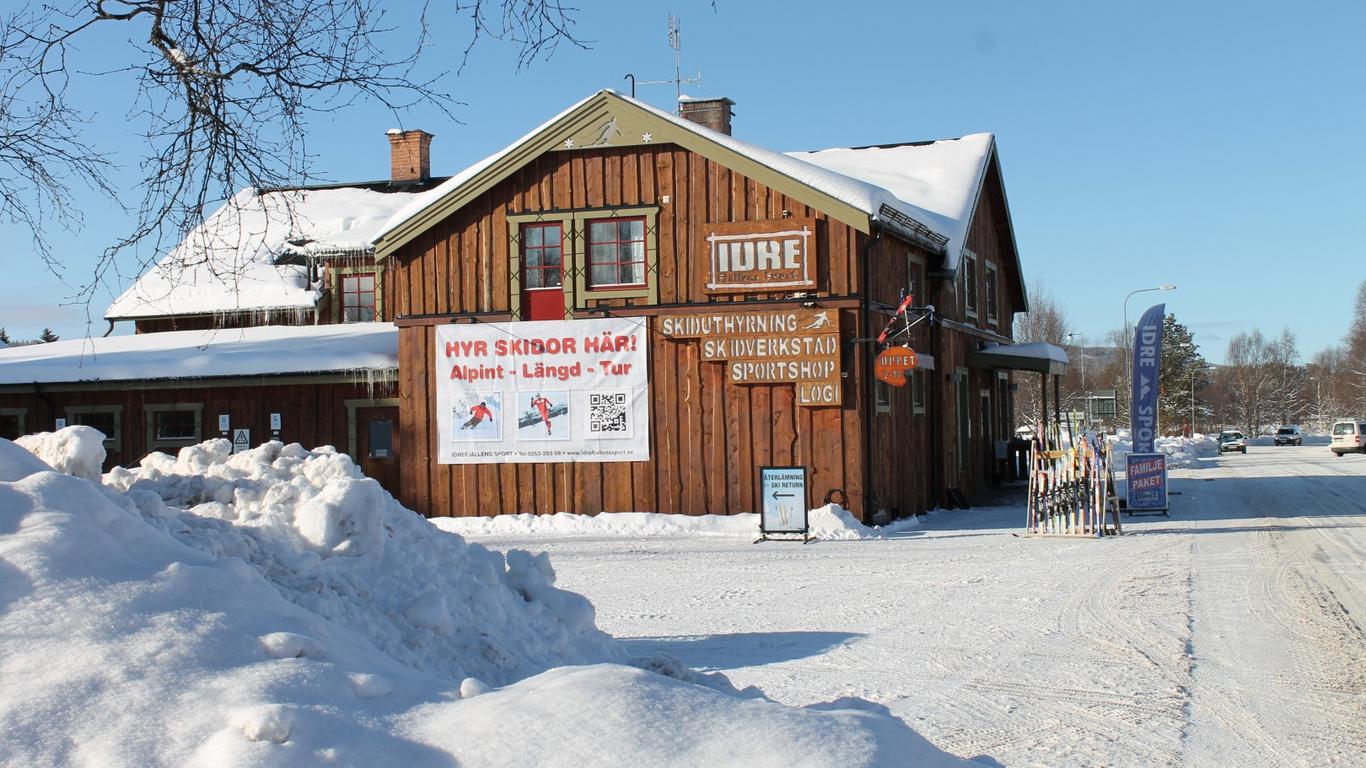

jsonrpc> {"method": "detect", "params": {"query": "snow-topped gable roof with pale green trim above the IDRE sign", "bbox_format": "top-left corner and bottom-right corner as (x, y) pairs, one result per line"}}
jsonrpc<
(374, 90), (994, 264)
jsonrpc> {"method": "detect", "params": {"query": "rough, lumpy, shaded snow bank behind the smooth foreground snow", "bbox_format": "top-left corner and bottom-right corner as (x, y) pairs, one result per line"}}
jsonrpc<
(108, 439), (620, 685)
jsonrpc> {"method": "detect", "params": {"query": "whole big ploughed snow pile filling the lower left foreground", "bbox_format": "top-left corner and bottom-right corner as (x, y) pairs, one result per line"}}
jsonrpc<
(0, 428), (964, 767)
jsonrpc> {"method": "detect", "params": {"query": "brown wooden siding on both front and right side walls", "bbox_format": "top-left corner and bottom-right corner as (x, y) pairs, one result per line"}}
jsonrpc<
(384, 145), (1019, 519)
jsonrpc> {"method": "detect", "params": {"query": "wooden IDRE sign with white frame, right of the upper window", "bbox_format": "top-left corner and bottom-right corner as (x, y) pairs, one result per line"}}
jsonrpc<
(702, 219), (816, 294)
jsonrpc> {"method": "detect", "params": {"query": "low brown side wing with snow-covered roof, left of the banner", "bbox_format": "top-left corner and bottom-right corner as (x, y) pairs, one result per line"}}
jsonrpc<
(0, 323), (402, 493)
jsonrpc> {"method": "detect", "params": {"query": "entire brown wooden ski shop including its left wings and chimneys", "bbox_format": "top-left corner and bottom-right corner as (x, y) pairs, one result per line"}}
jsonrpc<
(0, 90), (1056, 521)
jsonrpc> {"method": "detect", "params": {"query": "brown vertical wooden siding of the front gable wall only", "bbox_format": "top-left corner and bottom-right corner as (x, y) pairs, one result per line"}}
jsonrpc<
(385, 145), (866, 515)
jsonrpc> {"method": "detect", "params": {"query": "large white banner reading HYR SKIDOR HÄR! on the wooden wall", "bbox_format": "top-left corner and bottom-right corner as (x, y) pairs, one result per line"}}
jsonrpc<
(433, 318), (650, 465)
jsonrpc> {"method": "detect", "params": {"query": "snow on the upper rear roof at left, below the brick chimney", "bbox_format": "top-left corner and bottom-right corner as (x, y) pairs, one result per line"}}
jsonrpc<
(104, 187), (417, 320)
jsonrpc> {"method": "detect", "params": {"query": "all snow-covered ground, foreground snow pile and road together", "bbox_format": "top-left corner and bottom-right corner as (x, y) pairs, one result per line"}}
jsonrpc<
(0, 426), (1366, 767)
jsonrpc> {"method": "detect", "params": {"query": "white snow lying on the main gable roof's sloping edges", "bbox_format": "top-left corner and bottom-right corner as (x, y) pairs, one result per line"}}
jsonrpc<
(374, 89), (992, 256)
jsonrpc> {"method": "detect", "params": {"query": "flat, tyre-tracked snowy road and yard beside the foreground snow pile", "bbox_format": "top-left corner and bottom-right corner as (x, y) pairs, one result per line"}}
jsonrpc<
(461, 445), (1366, 767)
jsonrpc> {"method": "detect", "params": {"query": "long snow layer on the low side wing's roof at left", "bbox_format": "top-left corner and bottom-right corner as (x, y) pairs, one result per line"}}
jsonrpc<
(0, 323), (399, 384)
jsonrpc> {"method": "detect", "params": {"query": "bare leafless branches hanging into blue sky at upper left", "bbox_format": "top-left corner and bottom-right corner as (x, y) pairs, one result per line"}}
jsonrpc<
(0, 0), (576, 297)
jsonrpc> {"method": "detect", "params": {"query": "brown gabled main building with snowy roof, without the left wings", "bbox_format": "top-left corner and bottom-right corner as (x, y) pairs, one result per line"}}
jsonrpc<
(376, 90), (1026, 519)
